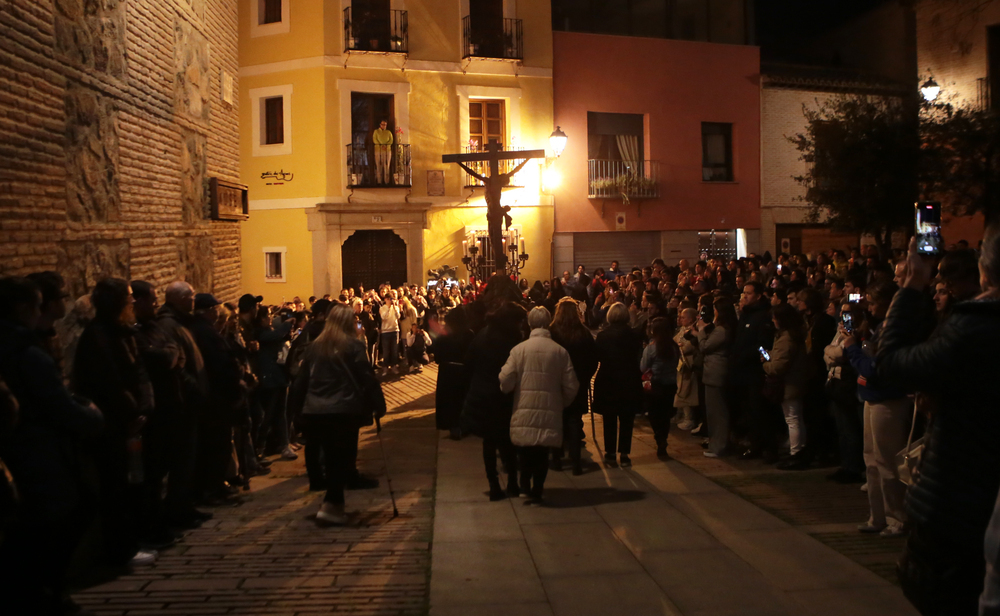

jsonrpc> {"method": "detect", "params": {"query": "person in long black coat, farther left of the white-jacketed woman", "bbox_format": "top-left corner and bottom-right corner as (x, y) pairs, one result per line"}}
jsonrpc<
(430, 306), (474, 440)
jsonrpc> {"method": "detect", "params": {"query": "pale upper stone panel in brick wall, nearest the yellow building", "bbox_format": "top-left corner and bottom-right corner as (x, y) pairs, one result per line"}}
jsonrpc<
(174, 19), (209, 121)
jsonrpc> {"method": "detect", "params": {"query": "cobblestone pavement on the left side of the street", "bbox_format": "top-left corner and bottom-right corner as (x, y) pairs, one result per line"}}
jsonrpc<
(74, 366), (438, 616)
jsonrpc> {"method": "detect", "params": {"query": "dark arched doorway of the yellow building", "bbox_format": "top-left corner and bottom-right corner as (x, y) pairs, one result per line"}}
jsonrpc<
(340, 230), (406, 289)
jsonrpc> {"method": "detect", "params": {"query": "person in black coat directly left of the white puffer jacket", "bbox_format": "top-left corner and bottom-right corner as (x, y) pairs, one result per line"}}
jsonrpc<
(462, 303), (527, 500)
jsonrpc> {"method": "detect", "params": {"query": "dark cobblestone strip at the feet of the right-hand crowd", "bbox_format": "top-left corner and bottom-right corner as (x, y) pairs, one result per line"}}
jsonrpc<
(632, 420), (906, 585)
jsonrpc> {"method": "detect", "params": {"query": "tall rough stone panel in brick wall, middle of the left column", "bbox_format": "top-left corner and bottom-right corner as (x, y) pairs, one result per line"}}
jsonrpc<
(66, 83), (121, 222)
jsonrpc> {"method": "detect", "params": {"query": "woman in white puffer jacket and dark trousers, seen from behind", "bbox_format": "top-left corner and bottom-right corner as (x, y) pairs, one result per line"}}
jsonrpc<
(500, 307), (580, 504)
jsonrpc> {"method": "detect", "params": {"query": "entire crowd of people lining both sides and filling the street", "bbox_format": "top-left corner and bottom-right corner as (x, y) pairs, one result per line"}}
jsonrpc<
(0, 236), (1000, 614)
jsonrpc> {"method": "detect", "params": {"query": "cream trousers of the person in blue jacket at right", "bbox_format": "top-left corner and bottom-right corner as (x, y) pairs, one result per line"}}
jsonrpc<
(864, 398), (913, 526)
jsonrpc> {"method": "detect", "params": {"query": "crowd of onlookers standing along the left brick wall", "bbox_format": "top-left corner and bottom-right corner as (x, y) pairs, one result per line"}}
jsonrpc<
(0, 280), (385, 614)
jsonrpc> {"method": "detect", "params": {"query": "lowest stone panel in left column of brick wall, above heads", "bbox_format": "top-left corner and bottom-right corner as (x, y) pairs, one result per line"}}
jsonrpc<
(57, 240), (130, 298)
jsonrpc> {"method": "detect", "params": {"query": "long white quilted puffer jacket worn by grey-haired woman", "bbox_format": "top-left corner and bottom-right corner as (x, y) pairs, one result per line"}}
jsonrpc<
(500, 327), (580, 447)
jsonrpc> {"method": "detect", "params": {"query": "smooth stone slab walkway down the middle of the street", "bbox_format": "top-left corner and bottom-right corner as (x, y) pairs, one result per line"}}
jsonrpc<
(430, 418), (916, 616)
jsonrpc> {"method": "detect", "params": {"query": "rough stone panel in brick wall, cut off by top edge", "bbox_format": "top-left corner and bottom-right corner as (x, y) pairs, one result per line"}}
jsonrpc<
(55, 0), (125, 79)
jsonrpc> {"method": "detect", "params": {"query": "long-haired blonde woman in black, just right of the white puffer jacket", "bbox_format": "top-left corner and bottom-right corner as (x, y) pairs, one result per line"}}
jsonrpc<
(549, 298), (597, 475)
